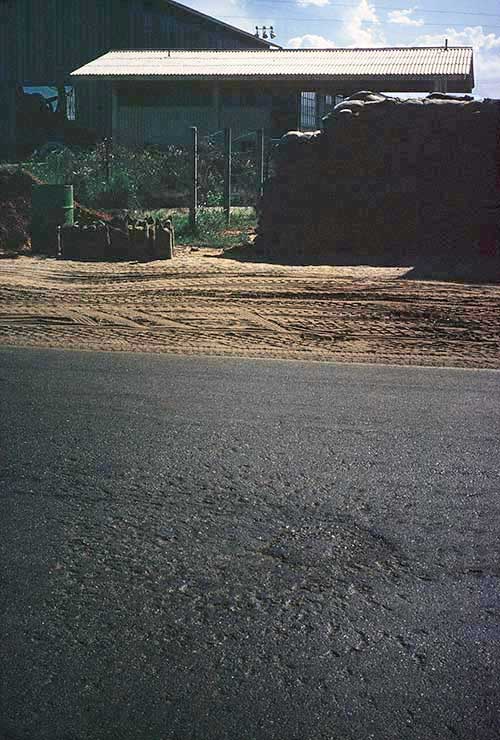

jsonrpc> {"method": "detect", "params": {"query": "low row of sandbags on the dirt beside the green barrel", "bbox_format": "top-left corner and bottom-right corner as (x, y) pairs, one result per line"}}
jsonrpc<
(58, 219), (175, 260)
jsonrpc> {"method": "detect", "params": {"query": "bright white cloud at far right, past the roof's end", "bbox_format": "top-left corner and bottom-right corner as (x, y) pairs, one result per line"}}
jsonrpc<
(416, 26), (500, 98)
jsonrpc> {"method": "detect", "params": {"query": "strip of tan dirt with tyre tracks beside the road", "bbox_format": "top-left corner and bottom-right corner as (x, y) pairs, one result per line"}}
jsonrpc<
(0, 249), (500, 368)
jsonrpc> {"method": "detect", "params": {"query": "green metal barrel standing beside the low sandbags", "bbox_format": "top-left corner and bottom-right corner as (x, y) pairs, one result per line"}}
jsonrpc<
(31, 185), (74, 254)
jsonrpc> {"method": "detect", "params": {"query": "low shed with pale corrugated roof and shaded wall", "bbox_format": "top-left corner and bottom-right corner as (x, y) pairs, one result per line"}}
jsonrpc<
(71, 45), (474, 147)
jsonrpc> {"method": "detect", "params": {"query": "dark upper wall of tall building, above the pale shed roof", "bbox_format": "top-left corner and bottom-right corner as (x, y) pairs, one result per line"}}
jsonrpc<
(7, 0), (265, 84)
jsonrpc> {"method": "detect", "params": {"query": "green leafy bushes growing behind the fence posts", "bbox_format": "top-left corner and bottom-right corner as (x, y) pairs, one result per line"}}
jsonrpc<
(23, 139), (262, 211)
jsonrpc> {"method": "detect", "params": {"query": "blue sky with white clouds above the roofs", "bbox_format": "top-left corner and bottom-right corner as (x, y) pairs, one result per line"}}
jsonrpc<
(185, 0), (500, 98)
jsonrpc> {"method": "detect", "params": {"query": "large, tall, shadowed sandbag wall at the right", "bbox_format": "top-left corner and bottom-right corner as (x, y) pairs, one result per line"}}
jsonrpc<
(255, 92), (500, 264)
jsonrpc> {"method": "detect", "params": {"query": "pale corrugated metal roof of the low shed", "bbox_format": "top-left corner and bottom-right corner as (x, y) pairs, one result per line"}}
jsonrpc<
(72, 46), (472, 80)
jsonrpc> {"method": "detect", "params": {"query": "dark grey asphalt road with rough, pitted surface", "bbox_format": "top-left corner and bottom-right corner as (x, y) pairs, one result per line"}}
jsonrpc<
(0, 349), (500, 740)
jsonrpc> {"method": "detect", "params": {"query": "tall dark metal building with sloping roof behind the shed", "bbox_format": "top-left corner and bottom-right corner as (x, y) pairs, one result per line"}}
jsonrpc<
(0, 0), (272, 159)
